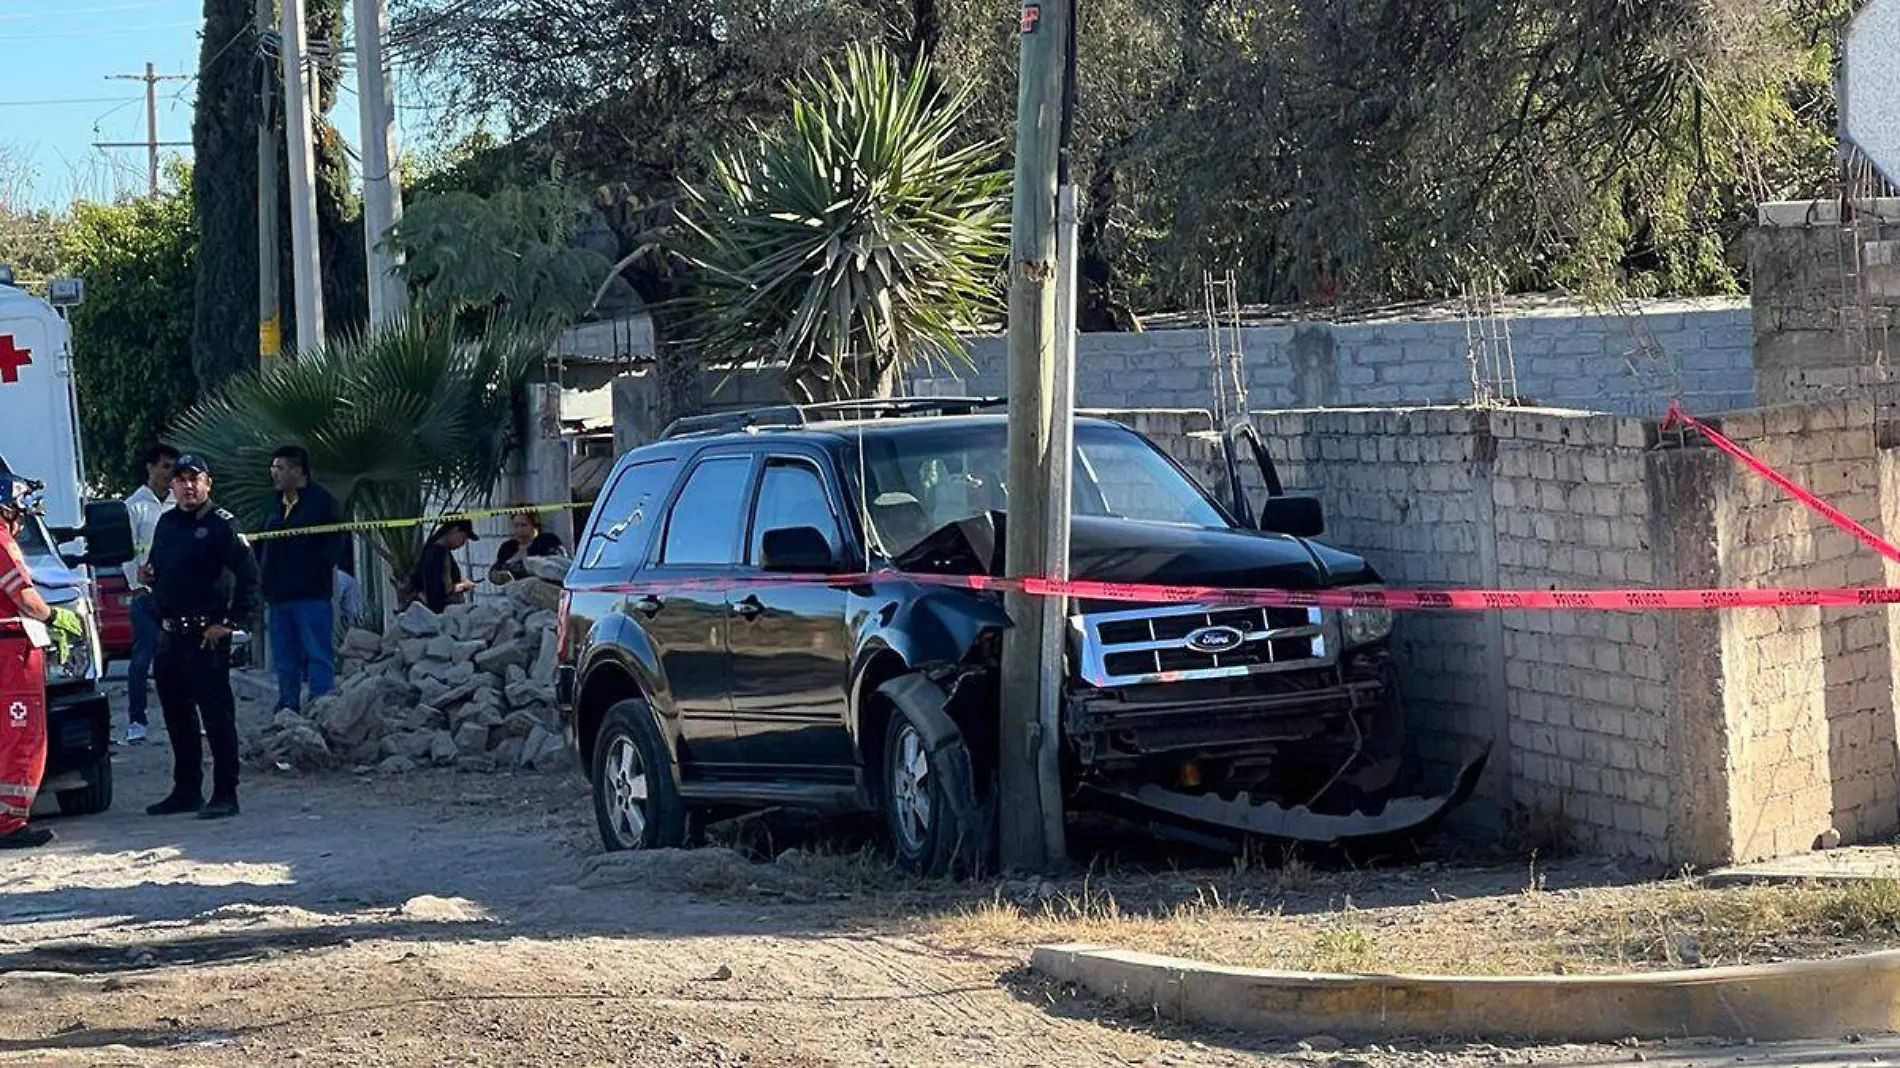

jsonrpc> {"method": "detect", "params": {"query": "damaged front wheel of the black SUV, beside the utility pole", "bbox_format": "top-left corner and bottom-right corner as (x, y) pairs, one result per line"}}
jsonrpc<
(878, 699), (980, 878)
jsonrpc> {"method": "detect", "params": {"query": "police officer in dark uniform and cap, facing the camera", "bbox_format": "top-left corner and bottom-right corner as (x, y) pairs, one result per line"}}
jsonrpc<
(144, 456), (258, 819)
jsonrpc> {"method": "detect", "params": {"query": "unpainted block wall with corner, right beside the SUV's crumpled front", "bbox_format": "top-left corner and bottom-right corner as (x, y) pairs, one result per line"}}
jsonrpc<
(1117, 395), (1900, 865)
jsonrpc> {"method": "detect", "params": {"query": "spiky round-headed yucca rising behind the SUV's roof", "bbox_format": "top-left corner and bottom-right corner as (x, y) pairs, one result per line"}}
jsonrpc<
(680, 46), (1009, 401)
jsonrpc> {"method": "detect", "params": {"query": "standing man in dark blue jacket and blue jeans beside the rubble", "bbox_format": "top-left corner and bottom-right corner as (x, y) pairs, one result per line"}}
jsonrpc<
(257, 445), (346, 711)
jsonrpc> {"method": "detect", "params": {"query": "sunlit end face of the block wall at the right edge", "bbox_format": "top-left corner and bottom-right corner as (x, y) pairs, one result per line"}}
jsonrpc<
(1714, 401), (1900, 857)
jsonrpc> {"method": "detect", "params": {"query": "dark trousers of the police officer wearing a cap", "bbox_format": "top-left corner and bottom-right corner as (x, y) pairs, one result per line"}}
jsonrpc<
(156, 629), (238, 798)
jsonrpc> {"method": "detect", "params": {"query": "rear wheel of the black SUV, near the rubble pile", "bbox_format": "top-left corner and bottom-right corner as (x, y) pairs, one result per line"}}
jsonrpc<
(589, 701), (686, 853)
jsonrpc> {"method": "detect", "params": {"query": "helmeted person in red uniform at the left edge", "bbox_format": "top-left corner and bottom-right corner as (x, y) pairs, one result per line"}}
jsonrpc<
(0, 473), (86, 849)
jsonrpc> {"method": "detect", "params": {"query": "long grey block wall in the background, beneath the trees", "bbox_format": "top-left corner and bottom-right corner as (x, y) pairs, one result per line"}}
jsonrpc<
(912, 300), (1756, 414)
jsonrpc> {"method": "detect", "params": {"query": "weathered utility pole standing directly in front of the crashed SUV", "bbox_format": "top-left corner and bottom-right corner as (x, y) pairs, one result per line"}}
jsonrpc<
(998, 0), (1074, 870)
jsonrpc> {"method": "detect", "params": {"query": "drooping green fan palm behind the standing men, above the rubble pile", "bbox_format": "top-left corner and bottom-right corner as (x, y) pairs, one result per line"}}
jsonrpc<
(173, 317), (555, 578)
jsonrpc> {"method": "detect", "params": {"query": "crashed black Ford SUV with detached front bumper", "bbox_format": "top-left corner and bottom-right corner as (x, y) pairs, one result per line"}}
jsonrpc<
(557, 399), (1484, 872)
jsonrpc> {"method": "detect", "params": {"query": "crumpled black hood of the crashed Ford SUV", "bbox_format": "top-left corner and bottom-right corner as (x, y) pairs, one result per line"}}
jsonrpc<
(891, 511), (1379, 589)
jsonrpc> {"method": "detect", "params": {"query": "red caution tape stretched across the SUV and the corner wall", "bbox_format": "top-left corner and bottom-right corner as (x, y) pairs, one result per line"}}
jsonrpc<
(576, 405), (1900, 612)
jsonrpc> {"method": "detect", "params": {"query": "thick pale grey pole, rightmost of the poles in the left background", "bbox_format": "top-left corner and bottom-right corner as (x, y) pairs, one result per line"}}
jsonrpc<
(352, 0), (409, 323)
